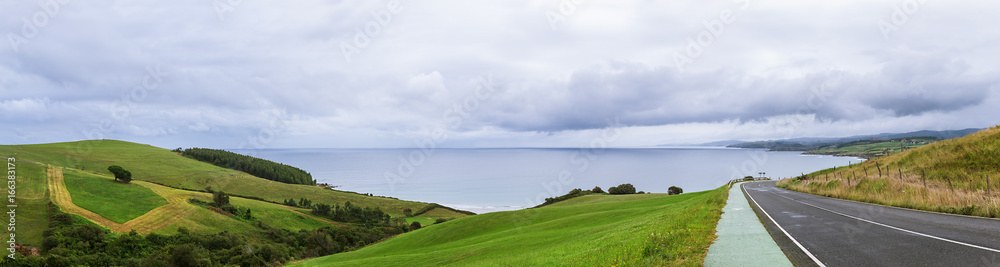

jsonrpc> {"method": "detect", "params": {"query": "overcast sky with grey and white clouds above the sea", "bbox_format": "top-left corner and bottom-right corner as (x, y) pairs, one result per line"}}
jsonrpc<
(0, 0), (1000, 148)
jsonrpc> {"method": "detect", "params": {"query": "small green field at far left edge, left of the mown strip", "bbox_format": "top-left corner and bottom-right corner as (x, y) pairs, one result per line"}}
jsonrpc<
(4, 161), (49, 246)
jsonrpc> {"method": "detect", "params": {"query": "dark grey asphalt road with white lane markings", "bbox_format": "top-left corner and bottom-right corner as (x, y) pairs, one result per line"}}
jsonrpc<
(743, 181), (1000, 266)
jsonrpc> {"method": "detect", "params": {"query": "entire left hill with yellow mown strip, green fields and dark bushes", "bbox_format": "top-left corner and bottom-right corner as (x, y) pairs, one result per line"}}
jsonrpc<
(0, 140), (476, 266)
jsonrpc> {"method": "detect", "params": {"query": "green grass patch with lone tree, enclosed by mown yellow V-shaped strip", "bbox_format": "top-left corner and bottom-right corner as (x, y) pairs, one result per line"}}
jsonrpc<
(63, 169), (167, 223)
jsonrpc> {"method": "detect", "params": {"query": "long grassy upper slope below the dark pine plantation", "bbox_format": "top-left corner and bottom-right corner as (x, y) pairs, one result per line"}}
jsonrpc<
(0, 140), (466, 218)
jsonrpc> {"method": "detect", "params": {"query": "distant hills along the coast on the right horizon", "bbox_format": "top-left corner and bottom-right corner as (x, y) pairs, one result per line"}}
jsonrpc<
(724, 128), (983, 151)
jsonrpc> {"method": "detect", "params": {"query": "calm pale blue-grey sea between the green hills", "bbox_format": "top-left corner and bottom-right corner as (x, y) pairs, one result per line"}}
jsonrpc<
(233, 148), (859, 213)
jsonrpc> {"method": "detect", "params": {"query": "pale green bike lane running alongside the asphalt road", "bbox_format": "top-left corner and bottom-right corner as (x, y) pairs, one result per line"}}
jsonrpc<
(705, 184), (792, 266)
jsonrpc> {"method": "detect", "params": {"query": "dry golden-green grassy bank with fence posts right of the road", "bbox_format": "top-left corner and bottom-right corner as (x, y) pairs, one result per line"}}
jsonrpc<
(778, 126), (1000, 217)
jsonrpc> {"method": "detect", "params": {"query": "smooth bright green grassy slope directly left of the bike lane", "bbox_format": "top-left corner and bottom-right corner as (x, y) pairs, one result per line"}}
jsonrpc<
(295, 188), (727, 266)
